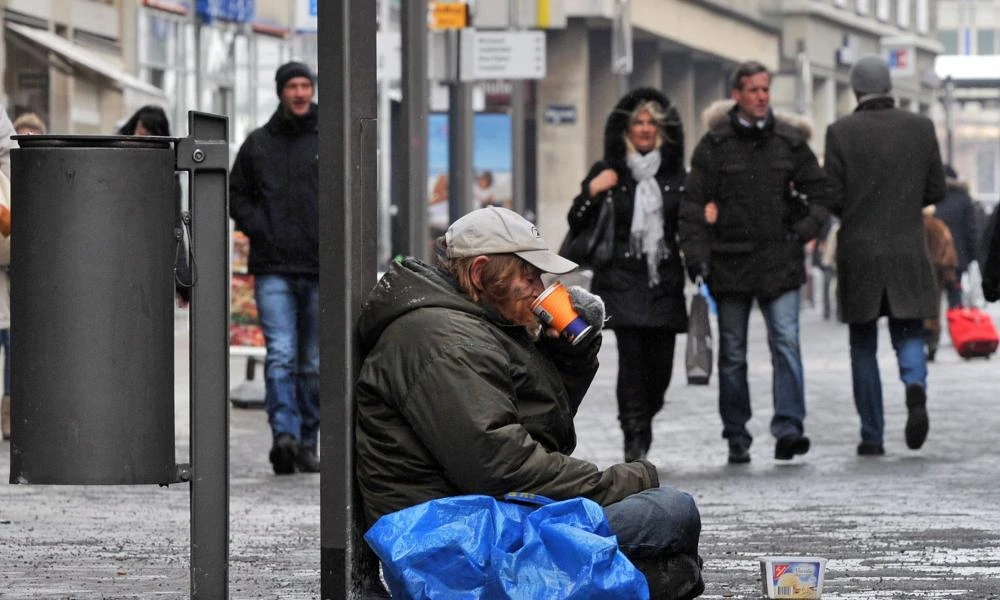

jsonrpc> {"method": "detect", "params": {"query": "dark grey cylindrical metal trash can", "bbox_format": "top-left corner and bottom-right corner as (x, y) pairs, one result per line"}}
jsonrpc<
(10, 135), (177, 484)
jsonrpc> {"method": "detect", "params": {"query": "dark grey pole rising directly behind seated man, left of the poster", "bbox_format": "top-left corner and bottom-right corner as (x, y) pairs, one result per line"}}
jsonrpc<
(397, 0), (429, 258)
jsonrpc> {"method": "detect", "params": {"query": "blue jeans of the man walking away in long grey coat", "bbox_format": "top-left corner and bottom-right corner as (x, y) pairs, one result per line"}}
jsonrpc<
(850, 317), (927, 444)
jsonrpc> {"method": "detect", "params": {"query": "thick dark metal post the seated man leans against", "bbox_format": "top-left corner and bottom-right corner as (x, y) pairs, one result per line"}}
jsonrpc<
(319, 0), (378, 599)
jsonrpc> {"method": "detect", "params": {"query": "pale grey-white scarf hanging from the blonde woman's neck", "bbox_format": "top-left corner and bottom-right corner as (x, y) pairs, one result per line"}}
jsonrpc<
(626, 150), (668, 287)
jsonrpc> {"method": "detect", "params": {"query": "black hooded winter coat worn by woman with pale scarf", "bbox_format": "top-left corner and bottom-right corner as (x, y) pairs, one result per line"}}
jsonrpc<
(568, 88), (687, 332)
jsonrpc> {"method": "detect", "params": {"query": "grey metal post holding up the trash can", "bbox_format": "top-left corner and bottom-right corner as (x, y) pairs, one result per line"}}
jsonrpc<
(177, 111), (229, 600)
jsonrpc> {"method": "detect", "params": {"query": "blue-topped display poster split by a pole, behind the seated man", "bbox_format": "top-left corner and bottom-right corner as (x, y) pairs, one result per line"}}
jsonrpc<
(427, 113), (513, 236)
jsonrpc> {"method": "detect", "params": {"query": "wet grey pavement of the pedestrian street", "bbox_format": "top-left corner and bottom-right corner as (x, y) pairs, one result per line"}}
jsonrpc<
(0, 298), (1000, 600)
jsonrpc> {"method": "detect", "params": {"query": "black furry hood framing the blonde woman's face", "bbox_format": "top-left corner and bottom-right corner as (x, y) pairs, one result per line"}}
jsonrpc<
(604, 88), (684, 172)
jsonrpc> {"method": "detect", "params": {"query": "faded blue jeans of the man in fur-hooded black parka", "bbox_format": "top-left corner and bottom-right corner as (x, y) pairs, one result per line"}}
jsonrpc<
(715, 290), (806, 443)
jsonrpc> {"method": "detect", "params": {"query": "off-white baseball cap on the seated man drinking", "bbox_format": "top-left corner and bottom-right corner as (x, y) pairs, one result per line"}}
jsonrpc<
(444, 206), (578, 274)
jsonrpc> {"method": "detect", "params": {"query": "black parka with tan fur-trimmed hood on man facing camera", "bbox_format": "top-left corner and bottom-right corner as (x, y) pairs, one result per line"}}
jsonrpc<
(680, 100), (828, 298)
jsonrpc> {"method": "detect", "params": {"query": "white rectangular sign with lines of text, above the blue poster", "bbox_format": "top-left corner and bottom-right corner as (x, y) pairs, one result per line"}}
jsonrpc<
(460, 29), (545, 81)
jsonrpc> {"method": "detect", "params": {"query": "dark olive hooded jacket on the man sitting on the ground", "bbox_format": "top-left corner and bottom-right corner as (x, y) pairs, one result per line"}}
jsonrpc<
(356, 258), (659, 525)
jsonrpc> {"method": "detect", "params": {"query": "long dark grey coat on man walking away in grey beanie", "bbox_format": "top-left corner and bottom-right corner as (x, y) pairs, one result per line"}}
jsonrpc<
(825, 97), (945, 323)
